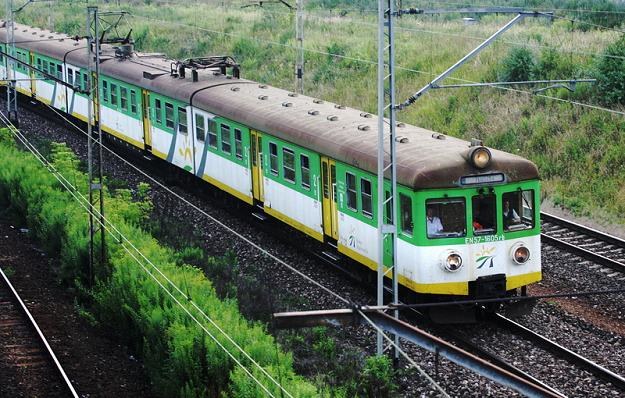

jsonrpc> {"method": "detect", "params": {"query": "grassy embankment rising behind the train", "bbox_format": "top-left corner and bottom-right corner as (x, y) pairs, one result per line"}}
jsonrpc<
(15, 2), (625, 224)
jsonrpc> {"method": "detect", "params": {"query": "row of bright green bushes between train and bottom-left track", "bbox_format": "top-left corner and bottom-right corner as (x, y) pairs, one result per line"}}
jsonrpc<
(0, 133), (318, 397)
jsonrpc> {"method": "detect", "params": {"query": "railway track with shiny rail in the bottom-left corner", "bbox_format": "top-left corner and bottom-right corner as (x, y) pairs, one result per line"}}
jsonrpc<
(0, 269), (78, 397)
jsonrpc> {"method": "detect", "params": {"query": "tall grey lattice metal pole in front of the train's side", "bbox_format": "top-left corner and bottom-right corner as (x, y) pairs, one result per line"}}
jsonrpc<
(377, 0), (399, 359)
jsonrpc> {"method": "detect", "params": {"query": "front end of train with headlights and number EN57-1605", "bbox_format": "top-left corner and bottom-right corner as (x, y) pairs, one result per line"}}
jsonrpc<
(399, 143), (541, 318)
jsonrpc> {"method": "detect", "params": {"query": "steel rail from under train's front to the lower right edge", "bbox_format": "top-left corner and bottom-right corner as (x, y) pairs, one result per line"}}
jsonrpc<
(493, 314), (625, 391)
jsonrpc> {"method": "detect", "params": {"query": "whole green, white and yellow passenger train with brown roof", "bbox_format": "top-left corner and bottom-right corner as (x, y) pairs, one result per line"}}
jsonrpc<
(0, 25), (541, 318)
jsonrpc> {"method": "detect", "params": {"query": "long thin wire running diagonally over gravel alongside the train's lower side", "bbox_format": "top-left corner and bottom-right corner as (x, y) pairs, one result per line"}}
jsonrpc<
(35, 98), (447, 396)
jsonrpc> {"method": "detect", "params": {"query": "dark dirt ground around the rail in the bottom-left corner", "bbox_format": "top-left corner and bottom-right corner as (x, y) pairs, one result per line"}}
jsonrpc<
(0, 218), (153, 398)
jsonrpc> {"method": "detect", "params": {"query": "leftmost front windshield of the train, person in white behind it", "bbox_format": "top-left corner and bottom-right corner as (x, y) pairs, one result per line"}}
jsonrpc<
(425, 198), (467, 239)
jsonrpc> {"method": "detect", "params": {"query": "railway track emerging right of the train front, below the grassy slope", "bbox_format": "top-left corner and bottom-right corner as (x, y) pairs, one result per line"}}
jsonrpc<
(540, 212), (625, 275)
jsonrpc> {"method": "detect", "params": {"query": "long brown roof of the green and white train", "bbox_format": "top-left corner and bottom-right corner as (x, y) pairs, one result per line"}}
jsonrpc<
(0, 24), (539, 189)
